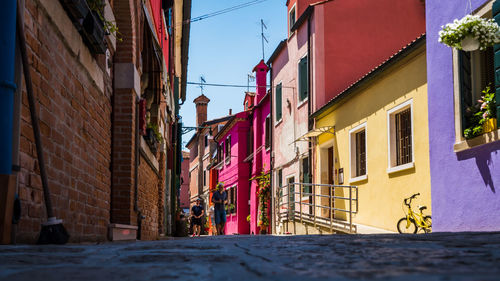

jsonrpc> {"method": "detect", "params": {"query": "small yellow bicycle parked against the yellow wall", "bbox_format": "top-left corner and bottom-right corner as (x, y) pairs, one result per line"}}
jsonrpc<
(397, 193), (432, 233)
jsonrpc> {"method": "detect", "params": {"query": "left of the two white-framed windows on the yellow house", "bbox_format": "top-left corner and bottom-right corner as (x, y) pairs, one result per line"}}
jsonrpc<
(349, 123), (366, 182)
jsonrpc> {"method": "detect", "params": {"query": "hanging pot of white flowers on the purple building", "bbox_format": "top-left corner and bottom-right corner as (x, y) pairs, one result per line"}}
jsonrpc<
(439, 15), (500, 51)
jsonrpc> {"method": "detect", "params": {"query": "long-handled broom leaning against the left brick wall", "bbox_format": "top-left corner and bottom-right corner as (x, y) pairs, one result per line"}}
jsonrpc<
(17, 5), (69, 244)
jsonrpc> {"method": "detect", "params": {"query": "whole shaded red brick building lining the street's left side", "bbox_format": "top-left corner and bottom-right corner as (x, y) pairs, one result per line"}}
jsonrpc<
(1, 0), (191, 243)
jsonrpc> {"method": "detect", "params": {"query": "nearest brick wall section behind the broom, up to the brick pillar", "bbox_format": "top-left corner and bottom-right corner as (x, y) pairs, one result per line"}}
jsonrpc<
(17, 0), (111, 243)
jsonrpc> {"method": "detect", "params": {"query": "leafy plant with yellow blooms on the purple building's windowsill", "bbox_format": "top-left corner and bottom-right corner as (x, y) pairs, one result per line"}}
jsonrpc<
(464, 86), (497, 139)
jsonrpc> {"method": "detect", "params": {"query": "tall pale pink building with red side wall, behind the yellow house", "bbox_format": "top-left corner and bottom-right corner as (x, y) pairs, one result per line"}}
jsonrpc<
(267, 0), (425, 232)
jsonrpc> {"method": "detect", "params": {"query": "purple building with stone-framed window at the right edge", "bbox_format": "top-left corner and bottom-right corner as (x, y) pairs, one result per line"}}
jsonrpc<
(426, 0), (500, 232)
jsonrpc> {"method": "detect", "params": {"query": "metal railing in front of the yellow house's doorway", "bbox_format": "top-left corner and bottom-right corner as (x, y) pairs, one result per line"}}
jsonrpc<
(276, 183), (358, 233)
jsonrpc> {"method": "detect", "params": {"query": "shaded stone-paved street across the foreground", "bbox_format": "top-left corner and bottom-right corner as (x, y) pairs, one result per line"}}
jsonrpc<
(0, 233), (500, 281)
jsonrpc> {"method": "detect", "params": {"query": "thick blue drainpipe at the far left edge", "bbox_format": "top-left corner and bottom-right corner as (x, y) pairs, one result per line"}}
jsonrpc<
(0, 0), (17, 175)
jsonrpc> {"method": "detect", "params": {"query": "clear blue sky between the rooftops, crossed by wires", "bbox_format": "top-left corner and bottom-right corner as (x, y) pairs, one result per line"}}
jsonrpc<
(180, 0), (286, 146)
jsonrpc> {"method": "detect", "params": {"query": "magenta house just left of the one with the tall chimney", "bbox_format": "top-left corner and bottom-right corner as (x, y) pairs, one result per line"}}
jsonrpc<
(215, 111), (251, 234)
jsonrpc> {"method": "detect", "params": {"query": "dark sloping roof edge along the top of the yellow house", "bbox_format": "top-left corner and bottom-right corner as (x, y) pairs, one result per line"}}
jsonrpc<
(310, 33), (426, 119)
